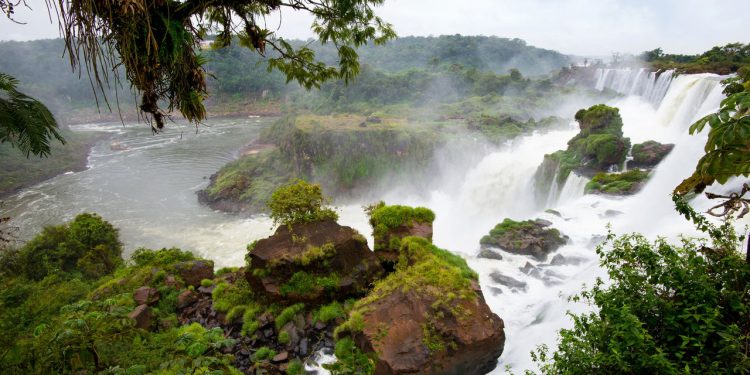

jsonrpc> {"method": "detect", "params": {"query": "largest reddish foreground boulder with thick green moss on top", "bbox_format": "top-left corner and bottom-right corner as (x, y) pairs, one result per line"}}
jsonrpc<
(337, 237), (505, 374)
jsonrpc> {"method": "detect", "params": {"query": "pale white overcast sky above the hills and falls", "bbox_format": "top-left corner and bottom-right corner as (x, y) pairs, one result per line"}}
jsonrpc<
(0, 0), (750, 56)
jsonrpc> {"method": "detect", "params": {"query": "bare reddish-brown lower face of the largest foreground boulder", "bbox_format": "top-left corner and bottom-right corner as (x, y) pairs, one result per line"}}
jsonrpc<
(354, 286), (505, 375)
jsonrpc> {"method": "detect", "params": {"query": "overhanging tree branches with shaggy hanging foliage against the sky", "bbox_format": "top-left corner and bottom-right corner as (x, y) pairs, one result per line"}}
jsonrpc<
(51, 0), (396, 131)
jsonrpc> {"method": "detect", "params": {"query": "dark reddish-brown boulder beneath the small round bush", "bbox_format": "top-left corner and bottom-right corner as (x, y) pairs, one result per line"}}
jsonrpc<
(245, 221), (383, 303)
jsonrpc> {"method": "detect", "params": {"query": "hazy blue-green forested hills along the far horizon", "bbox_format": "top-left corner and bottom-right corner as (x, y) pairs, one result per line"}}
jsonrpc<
(0, 35), (571, 121)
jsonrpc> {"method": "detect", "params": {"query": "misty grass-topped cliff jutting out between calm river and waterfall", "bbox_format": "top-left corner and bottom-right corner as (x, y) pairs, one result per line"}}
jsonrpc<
(198, 115), (443, 212)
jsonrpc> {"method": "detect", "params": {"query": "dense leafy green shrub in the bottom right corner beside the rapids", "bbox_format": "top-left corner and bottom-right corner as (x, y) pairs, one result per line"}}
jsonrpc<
(534, 206), (750, 374)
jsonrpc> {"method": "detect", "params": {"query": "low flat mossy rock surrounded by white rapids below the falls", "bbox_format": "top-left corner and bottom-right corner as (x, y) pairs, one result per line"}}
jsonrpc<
(479, 219), (567, 260)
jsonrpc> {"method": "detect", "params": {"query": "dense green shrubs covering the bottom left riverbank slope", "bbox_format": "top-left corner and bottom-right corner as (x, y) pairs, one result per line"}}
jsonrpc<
(0, 214), (248, 374)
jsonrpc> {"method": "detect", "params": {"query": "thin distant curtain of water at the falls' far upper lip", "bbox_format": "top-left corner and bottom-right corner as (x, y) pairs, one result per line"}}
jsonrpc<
(594, 68), (674, 107)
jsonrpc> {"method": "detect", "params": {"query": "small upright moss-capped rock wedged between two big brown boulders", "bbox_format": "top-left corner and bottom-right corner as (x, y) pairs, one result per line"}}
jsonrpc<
(367, 201), (435, 270)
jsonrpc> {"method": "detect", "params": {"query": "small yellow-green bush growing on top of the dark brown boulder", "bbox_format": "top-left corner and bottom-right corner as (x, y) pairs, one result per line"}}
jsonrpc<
(268, 180), (339, 225)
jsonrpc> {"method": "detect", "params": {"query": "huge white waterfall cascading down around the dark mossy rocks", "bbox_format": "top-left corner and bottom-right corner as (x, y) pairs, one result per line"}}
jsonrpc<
(376, 70), (736, 374)
